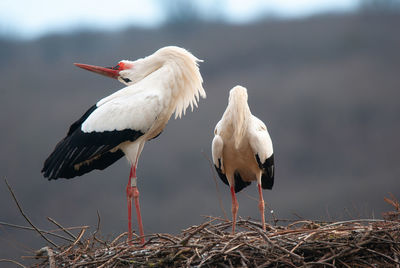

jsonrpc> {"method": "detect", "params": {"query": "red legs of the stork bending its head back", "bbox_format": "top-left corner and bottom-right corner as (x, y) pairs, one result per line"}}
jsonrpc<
(126, 164), (144, 244)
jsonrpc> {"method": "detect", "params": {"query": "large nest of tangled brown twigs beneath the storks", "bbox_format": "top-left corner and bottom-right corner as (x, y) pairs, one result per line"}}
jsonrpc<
(26, 215), (400, 268)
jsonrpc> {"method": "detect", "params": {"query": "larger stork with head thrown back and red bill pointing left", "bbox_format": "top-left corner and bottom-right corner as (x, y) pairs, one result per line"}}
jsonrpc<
(42, 46), (206, 243)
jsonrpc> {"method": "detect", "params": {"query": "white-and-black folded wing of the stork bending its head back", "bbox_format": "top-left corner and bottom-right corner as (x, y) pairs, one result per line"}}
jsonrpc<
(42, 90), (162, 179)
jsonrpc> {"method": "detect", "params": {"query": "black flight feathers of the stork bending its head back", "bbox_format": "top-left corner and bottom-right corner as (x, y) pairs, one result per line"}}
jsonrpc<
(42, 105), (144, 180)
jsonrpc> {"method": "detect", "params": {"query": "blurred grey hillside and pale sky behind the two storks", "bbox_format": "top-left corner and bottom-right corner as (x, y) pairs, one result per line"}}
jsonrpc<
(0, 0), (400, 262)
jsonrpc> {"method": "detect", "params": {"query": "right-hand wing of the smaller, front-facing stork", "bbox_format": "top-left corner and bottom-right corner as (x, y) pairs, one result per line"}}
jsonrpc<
(249, 116), (275, 189)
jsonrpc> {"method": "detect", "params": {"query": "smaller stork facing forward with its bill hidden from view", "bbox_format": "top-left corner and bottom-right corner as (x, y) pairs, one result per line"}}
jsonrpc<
(212, 86), (274, 233)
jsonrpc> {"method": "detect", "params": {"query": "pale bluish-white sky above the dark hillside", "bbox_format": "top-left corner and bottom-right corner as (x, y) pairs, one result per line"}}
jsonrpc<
(0, 0), (358, 38)
